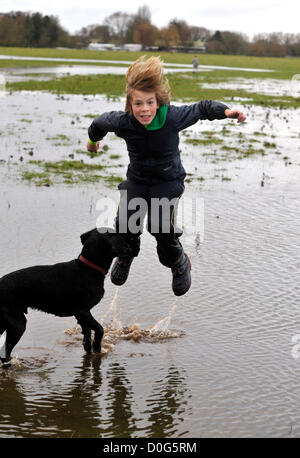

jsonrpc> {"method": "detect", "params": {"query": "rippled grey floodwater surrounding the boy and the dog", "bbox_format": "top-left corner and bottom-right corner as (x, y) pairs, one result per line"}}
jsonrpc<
(0, 81), (300, 438)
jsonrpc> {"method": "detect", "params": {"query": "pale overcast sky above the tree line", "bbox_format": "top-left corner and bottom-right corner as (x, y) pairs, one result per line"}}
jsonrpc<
(0, 0), (300, 38)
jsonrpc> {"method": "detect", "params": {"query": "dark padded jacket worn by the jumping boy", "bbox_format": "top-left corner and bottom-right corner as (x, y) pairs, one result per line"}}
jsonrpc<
(88, 100), (228, 184)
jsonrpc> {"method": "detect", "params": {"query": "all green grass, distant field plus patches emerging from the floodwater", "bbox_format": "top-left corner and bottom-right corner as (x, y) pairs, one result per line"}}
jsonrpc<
(0, 48), (300, 187)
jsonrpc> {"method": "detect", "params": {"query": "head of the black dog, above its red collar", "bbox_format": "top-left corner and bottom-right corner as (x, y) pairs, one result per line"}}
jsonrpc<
(80, 227), (132, 270)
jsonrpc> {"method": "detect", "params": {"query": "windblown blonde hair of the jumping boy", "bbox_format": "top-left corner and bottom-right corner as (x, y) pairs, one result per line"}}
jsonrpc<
(125, 56), (171, 114)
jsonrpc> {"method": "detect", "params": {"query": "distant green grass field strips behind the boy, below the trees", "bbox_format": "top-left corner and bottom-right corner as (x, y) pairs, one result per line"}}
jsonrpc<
(0, 47), (300, 108)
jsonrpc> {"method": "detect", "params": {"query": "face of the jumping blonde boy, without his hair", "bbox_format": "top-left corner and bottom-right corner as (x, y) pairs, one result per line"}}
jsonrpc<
(131, 89), (159, 125)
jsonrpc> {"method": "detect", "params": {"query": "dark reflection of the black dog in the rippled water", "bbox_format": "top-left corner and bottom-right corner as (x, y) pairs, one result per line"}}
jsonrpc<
(0, 355), (101, 437)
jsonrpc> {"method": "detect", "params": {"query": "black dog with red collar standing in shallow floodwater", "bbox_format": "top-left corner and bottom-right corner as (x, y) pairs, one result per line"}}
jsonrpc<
(0, 228), (131, 365)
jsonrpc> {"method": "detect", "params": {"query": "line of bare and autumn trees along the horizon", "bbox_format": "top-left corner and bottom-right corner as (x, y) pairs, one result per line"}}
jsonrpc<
(0, 5), (300, 57)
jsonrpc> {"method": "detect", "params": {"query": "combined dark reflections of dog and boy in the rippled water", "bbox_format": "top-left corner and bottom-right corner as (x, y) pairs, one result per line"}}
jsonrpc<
(0, 355), (188, 438)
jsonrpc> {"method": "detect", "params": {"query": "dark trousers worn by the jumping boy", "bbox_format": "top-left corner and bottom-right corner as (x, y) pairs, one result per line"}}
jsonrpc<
(115, 180), (184, 267)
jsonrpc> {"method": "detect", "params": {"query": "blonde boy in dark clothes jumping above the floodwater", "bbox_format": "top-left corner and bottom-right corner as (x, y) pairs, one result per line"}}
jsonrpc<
(87, 56), (246, 296)
